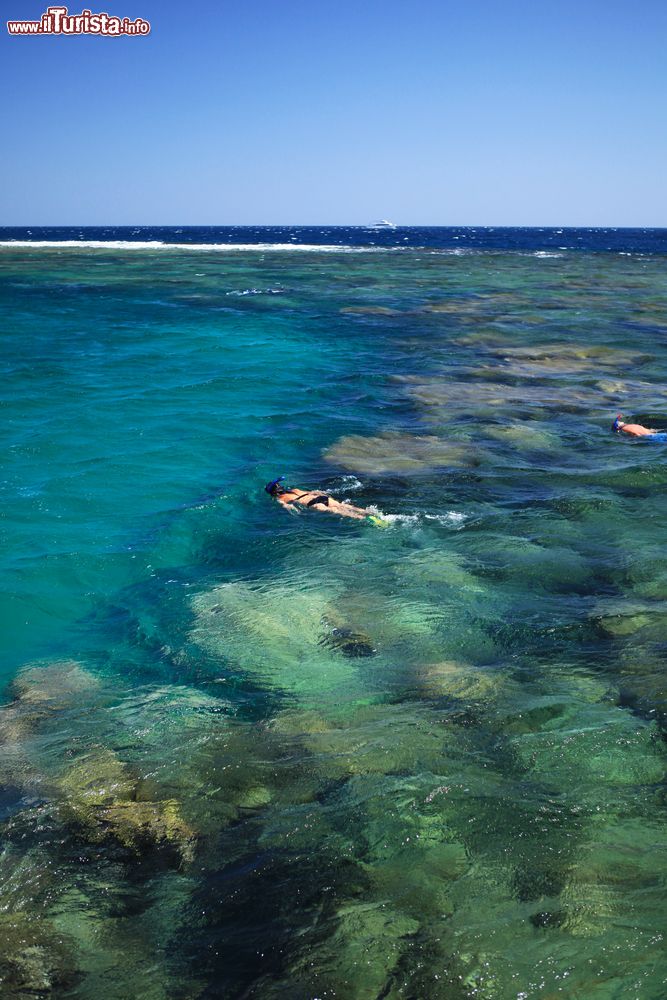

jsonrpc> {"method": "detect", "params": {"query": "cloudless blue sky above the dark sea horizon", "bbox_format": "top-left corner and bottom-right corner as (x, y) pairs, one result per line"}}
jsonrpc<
(0, 0), (667, 226)
